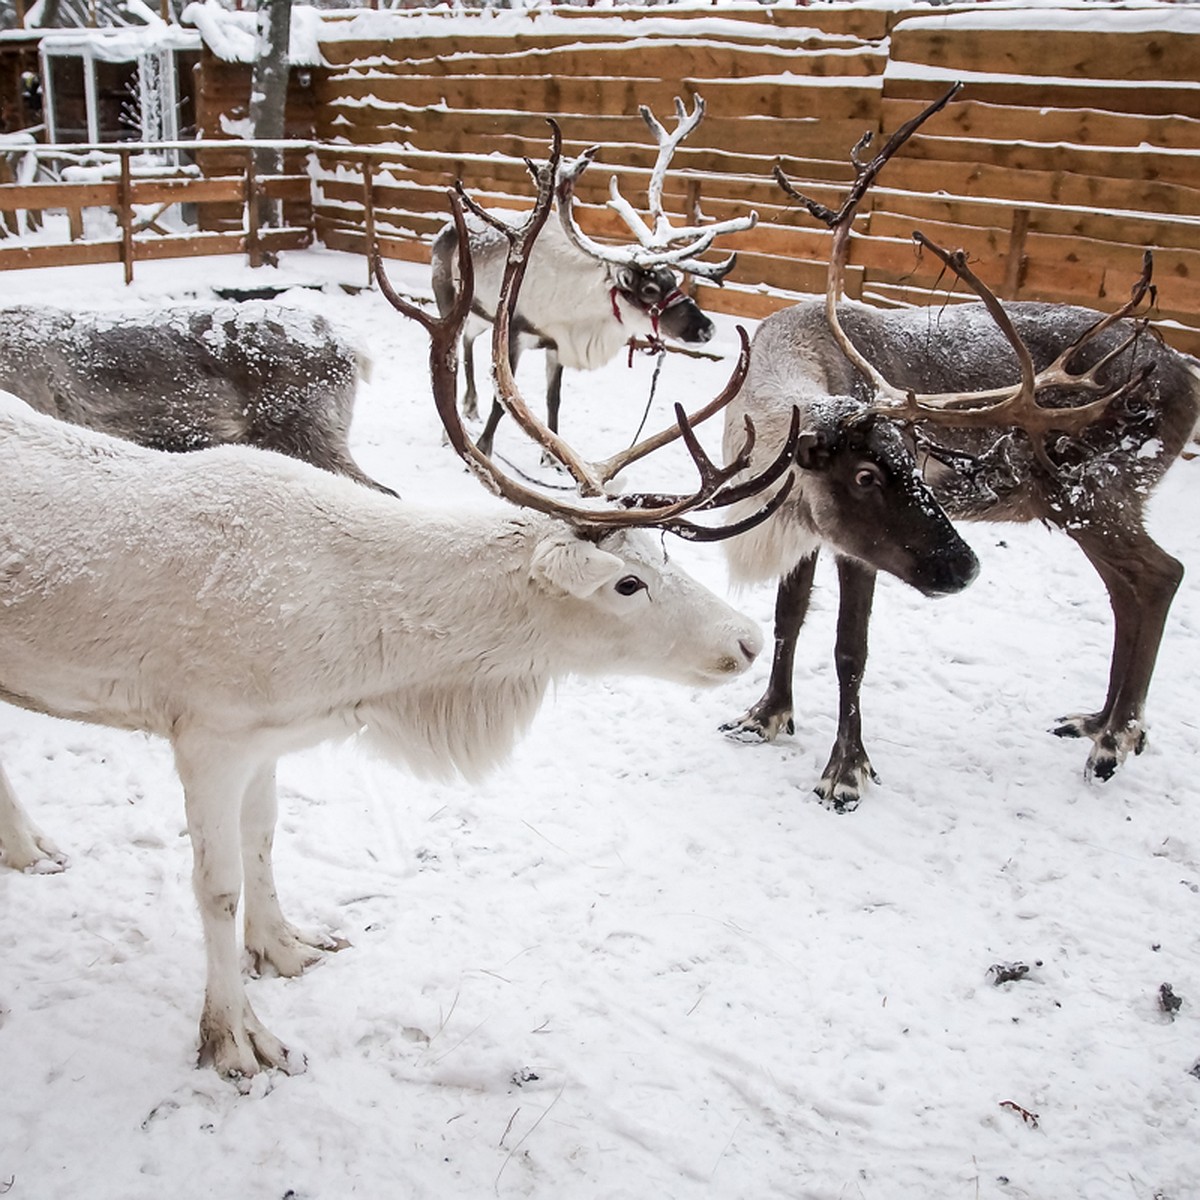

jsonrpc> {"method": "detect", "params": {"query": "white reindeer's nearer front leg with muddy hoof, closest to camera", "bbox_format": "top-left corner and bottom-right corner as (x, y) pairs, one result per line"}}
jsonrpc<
(175, 732), (304, 1080)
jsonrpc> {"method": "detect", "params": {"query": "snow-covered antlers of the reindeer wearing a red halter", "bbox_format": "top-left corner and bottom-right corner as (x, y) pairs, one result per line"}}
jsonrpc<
(558, 96), (758, 283)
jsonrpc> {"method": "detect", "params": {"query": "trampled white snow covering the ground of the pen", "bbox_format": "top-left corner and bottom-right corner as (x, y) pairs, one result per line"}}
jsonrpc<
(0, 253), (1200, 1200)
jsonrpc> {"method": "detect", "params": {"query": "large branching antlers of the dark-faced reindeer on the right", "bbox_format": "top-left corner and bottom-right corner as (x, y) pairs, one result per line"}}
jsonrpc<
(774, 83), (1154, 446)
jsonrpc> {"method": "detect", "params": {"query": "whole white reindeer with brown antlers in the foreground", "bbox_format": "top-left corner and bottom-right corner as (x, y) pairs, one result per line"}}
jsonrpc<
(0, 147), (794, 1079)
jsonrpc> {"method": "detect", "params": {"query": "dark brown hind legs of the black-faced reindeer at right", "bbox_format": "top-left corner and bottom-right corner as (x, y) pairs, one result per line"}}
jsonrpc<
(1054, 518), (1183, 780)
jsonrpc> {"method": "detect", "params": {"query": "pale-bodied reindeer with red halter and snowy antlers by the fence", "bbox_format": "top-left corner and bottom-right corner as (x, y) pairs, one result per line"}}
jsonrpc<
(432, 96), (757, 454)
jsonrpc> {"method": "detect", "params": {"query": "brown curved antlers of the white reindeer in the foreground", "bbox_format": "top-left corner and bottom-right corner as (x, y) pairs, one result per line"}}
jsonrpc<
(376, 121), (799, 540)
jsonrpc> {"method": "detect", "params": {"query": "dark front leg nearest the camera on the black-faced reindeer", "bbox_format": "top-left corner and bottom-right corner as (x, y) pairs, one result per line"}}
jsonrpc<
(814, 558), (878, 812)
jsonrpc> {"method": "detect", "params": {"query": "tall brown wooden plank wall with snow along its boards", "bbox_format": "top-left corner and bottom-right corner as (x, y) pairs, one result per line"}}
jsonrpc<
(0, 2), (1200, 353)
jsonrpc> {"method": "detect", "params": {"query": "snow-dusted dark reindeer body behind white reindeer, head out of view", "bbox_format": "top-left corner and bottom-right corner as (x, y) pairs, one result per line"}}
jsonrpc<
(0, 300), (395, 494)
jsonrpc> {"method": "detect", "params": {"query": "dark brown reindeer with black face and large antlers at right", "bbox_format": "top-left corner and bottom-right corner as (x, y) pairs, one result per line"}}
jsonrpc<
(725, 89), (1200, 809)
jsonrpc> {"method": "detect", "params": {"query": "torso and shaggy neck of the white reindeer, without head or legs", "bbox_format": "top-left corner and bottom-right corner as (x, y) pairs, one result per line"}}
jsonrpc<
(0, 398), (628, 775)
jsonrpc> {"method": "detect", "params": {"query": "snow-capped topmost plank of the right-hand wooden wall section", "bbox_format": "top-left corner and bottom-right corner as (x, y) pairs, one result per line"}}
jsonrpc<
(892, 17), (1200, 83)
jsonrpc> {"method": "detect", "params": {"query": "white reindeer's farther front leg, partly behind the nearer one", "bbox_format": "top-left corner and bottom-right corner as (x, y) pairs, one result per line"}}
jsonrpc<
(241, 763), (350, 977)
